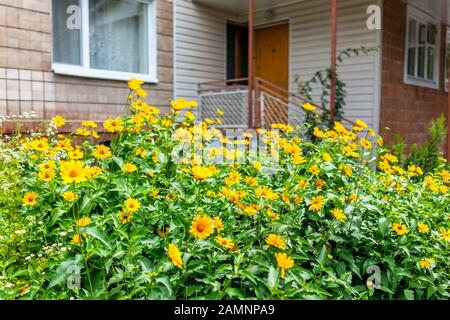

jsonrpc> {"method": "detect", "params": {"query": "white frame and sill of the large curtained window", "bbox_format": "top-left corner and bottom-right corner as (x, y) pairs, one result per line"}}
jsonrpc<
(52, 0), (158, 83)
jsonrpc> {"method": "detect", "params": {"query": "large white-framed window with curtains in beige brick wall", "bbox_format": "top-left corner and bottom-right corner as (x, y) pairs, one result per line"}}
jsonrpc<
(52, 0), (157, 82)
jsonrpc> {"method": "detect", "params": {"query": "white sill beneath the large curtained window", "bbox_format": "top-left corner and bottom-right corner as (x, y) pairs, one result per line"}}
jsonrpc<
(52, 63), (158, 84)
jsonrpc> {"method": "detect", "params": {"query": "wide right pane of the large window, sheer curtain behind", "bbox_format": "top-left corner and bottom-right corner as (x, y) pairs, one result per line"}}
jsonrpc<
(89, 0), (148, 73)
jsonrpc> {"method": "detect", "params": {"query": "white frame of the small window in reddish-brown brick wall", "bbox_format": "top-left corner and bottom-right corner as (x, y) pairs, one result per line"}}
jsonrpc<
(404, 6), (441, 89)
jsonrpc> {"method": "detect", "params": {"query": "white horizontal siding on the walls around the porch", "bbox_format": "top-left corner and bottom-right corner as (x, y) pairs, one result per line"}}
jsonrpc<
(175, 0), (380, 128)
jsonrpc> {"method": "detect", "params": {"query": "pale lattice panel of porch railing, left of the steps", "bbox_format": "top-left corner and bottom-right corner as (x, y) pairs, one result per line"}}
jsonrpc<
(198, 90), (248, 128)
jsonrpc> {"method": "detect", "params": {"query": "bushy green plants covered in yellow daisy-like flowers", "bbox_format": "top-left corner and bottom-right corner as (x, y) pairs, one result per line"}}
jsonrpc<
(0, 79), (450, 299)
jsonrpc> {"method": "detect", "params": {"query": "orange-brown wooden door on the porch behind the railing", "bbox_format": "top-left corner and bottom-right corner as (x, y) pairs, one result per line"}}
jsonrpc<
(255, 23), (289, 124)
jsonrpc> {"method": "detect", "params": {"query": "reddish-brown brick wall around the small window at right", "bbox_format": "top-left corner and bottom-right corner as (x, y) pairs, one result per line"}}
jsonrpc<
(380, 0), (447, 145)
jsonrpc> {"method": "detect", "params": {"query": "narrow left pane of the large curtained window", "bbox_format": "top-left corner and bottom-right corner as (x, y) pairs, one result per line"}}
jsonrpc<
(52, 0), (81, 65)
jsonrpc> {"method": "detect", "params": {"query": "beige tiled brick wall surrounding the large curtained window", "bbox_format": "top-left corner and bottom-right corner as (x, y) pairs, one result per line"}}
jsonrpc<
(0, 0), (173, 124)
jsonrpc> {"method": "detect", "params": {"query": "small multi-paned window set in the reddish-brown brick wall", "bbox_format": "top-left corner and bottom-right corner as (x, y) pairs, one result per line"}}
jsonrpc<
(405, 7), (440, 89)
